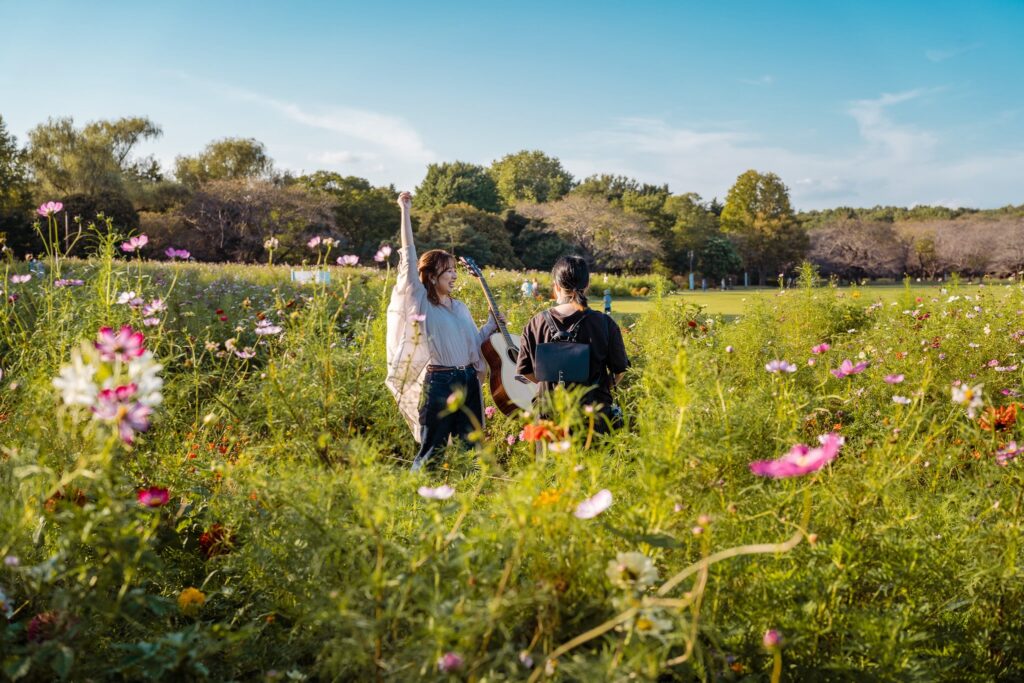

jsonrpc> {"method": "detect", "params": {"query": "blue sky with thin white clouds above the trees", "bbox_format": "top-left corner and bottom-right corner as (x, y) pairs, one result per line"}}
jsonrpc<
(0, 0), (1024, 209)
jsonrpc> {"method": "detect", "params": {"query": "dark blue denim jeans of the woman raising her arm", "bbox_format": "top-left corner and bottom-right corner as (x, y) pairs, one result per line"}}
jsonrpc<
(412, 368), (483, 472)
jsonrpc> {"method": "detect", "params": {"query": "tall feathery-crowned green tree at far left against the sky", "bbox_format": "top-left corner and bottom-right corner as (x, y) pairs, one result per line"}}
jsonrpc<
(28, 117), (162, 199)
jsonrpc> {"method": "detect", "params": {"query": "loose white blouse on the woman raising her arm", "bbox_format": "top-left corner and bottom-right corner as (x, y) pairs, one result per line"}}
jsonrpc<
(384, 224), (498, 441)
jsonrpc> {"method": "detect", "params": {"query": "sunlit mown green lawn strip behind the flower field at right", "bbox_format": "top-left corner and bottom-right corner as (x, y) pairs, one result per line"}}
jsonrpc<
(610, 282), (978, 318)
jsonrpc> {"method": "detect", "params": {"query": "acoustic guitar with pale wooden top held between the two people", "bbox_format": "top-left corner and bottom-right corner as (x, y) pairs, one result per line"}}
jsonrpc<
(459, 257), (538, 415)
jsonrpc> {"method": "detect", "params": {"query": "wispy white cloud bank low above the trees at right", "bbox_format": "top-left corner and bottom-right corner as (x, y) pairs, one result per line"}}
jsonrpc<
(563, 89), (1024, 209)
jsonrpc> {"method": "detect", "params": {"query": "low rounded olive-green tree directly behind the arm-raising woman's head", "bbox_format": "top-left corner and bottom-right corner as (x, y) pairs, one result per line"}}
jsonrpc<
(416, 204), (522, 268)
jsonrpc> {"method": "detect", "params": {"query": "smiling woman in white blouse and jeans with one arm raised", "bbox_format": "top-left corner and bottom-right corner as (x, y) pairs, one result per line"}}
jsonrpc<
(385, 193), (498, 472)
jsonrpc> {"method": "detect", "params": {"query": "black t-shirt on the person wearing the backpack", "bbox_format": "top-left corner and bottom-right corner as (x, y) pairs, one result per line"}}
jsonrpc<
(516, 308), (630, 405)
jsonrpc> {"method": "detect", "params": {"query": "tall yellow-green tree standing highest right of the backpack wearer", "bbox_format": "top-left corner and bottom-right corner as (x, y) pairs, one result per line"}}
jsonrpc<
(721, 170), (808, 285)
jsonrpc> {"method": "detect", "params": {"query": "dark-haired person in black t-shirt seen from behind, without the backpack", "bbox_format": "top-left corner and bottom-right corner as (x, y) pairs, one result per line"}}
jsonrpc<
(516, 256), (630, 432)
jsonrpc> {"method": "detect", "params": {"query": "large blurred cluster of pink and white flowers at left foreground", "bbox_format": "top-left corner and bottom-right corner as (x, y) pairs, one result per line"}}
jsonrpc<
(53, 326), (164, 443)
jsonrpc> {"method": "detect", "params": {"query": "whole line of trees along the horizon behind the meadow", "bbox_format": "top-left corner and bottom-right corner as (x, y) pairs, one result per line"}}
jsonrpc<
(0, 117), (1024, 284)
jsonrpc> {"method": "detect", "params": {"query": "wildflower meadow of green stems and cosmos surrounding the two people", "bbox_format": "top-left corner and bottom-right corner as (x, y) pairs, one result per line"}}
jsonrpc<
(0, 210), (1024, 681)
